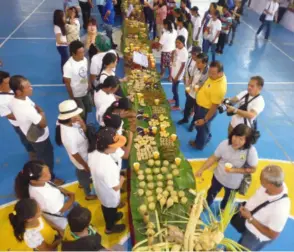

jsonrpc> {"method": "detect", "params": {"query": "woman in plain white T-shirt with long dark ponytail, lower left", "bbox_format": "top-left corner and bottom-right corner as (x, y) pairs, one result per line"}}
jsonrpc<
(14, 160), (77, 230)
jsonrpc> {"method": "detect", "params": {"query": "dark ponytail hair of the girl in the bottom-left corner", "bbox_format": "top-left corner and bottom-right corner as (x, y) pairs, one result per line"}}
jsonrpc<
(8, 198), (38, 242)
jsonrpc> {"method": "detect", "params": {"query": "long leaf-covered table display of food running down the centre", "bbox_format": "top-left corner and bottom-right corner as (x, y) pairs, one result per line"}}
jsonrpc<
(122, 0), (246, 251)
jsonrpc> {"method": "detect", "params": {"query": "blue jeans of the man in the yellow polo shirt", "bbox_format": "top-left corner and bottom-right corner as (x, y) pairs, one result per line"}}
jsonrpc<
(191, 104), (216, 150)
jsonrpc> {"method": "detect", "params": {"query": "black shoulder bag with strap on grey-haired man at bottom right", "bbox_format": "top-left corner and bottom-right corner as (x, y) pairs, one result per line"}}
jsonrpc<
(231, 194), (288, 233)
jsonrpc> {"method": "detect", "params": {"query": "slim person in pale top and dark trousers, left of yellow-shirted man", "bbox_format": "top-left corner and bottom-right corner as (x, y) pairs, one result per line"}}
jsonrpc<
(178, 46), (201, 125)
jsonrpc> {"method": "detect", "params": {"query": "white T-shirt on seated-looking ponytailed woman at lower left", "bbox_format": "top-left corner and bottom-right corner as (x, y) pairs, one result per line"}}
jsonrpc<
(29, 183), (64, 214)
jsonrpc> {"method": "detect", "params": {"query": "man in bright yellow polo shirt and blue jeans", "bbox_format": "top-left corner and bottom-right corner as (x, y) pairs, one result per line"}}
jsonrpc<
(189, 61), (227, 150)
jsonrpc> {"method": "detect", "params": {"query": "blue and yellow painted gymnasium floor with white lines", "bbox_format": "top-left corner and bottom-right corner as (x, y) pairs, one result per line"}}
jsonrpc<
(0, 0), (294, 251)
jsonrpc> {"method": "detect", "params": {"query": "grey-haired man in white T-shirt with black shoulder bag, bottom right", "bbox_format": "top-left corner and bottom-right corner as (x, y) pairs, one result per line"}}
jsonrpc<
(238, 165), (291, 251)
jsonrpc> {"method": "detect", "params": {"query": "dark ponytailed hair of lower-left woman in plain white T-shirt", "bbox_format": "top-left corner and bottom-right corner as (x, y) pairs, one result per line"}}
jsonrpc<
(14, 160), (46, 199)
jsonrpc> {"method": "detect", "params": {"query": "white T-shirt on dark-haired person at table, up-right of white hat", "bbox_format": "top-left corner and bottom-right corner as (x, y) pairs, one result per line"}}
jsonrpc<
(94, 89), (116, 123)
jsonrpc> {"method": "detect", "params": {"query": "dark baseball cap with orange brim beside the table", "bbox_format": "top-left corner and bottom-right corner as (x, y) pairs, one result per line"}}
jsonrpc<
(96, 127), (127, 151)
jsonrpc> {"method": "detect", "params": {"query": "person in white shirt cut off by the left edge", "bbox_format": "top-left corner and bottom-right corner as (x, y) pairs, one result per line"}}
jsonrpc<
(0, 71), (36, 160)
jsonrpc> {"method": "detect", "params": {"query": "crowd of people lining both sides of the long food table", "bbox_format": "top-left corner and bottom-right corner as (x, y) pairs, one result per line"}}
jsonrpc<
(0, 0), (290, 251)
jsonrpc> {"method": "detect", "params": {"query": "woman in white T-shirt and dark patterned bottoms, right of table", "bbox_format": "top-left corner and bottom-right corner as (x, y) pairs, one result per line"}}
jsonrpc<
(159, 19), (177, 78)
